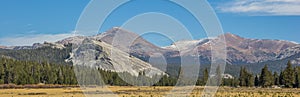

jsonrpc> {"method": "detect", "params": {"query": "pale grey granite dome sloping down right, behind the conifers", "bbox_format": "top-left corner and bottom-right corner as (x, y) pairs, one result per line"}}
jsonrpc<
(71, 38), (165, 77)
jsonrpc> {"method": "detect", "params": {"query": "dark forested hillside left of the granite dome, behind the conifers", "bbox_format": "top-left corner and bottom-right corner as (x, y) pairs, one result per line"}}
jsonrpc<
(0, 45), (72, 65)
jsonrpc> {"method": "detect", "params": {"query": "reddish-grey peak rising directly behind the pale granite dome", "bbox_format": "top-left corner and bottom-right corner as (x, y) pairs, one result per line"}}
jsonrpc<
(93, 27), (170, 61)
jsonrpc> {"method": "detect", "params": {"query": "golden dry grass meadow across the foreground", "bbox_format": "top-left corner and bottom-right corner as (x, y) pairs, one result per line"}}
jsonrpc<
(0, 86), (300, 97)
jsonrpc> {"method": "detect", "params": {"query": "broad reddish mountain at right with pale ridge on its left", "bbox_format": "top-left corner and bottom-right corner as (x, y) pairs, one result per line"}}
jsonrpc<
(164, 33), (300, 64)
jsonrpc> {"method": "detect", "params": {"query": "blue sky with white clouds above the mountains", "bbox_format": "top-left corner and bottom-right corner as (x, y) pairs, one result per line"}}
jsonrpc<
(0, 0), (300, 46)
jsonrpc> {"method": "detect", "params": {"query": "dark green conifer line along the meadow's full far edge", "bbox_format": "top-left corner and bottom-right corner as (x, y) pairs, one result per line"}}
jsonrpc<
(0, 57), (300, 88)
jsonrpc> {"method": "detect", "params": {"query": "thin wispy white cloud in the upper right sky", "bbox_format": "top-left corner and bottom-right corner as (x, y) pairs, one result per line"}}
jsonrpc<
(217, 0), (300, 16)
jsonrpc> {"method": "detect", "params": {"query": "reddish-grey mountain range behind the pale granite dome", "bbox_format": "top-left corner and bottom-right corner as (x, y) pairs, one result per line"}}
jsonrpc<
(56, 27), (300, 64)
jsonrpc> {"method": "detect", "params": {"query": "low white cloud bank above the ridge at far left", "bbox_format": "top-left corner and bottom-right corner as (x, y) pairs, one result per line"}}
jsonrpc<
(0, 33), (74, 46)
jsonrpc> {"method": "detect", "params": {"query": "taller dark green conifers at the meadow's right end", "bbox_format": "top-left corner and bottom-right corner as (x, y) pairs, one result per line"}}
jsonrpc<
(218, 62), (300, 88)
